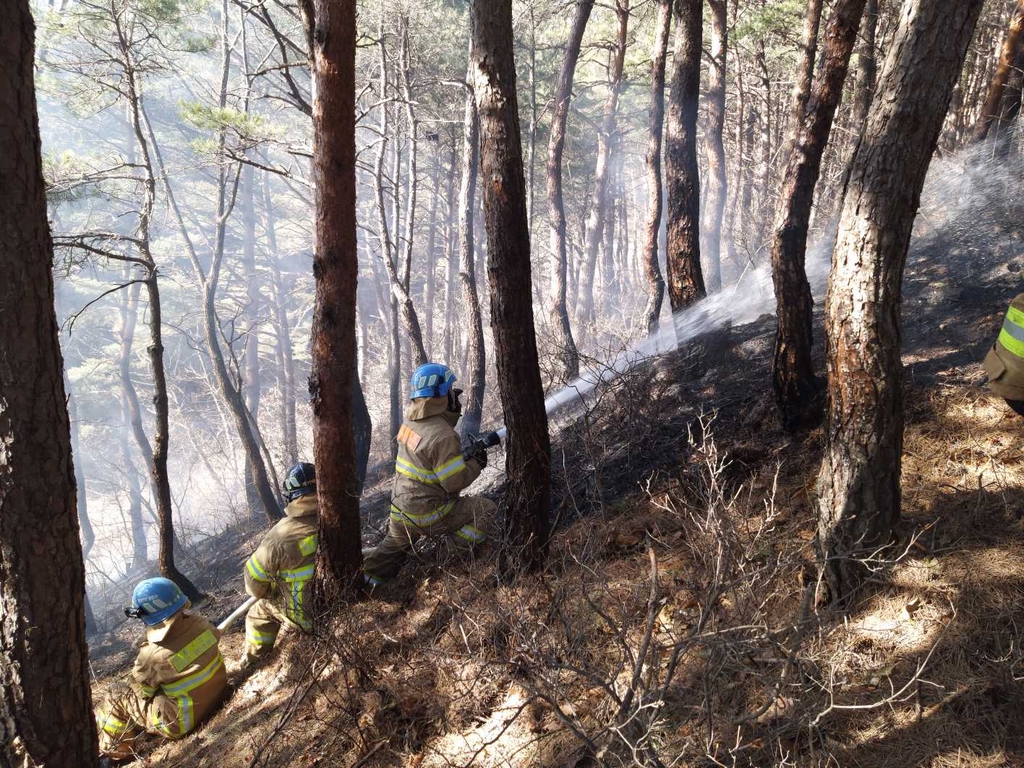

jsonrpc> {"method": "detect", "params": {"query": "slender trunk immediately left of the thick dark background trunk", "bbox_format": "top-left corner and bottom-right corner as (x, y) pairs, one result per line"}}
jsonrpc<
(643, 0), (672, 334)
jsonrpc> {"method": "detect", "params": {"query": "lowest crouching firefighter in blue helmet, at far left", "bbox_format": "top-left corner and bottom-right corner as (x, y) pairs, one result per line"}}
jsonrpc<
(96, 578), (227, 760)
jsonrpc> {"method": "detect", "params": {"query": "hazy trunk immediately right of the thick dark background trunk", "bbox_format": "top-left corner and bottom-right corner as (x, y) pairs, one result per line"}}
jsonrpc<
(703, 0), (729, 292)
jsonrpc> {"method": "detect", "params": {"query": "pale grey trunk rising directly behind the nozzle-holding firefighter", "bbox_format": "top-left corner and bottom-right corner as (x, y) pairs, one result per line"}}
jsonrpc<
(459, 75), (487, 442)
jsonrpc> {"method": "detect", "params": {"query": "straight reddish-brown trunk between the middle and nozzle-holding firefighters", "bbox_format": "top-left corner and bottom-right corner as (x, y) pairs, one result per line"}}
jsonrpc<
(309, 0), (362, 608)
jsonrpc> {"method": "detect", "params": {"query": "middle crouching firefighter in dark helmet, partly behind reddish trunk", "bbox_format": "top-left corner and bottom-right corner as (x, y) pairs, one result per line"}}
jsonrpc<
(242, 462), (319, 667)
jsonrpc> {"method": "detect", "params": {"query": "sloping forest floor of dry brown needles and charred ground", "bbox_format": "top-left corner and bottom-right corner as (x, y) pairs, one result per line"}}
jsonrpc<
(93, 211), (1024, 767)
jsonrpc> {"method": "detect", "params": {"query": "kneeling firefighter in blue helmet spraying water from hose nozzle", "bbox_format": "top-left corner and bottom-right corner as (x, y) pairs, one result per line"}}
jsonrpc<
(364, 362), (496, 587)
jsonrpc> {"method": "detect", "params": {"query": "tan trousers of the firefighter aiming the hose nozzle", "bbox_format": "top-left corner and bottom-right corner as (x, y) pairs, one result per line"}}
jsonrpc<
(362, 496), (498, 587)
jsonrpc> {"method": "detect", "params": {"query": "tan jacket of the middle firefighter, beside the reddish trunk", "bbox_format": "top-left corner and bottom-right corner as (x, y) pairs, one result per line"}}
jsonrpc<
(246, 494), (319, 632)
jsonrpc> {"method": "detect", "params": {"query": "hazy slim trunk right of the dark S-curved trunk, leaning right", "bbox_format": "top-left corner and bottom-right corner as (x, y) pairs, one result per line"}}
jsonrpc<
(579, 0), (630, 325)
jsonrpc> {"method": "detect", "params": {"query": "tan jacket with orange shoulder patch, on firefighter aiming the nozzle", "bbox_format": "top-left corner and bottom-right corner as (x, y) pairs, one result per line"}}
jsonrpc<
(391, 397), (480, 527)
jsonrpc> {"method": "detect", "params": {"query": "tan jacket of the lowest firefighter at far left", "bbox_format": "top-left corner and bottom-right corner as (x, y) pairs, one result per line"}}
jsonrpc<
(131, 609), (227, 738)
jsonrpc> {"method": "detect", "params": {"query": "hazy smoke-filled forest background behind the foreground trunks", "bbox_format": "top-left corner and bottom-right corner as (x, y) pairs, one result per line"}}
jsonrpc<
(32, 0), (1019, 626)
